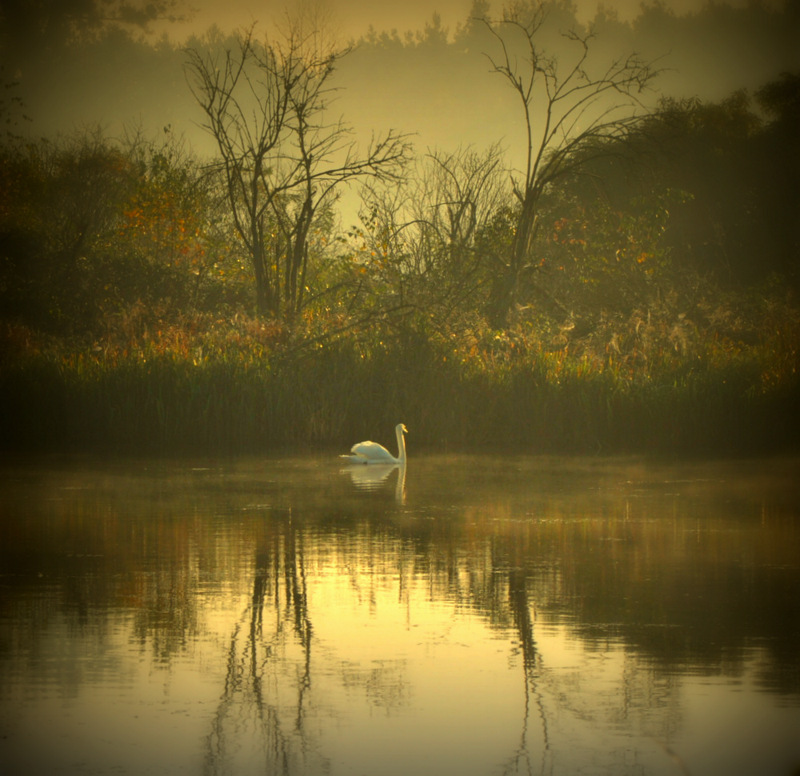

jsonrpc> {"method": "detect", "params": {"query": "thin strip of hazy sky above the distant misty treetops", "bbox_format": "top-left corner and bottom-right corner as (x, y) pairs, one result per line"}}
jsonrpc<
(156, 0), (772, 39)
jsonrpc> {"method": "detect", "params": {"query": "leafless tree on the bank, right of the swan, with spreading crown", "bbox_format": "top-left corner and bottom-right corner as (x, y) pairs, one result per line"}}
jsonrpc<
(483, 2), (657, 325)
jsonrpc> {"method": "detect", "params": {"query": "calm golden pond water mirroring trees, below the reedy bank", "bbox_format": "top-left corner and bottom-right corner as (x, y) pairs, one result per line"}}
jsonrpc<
(0, 457), (800, 776)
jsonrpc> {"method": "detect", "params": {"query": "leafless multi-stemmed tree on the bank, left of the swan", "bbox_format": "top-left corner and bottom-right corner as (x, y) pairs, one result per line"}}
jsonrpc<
(187, 22), (408, 320)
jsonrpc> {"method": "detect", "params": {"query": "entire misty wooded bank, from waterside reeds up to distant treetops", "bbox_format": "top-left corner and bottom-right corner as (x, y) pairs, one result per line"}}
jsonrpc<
(0, 0), (800, 454)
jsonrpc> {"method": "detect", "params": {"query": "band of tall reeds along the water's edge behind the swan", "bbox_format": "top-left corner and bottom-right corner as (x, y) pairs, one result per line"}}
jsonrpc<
(0, 316), (800, 452)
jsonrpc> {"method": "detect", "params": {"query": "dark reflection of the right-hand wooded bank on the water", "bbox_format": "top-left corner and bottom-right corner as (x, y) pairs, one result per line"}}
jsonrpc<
(404, 484), (800, 692)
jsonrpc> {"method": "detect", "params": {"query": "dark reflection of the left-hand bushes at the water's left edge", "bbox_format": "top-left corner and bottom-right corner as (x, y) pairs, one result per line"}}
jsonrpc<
(0, 489), (206, 661)
